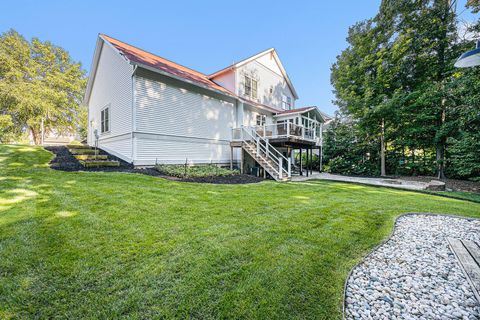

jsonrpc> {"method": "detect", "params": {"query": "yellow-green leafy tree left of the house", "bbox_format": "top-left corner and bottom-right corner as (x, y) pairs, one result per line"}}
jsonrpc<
(0, 30), (86, 144)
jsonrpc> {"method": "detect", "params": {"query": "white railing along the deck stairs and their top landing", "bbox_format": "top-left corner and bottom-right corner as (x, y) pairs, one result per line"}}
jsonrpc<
(238, 126), (292, 179)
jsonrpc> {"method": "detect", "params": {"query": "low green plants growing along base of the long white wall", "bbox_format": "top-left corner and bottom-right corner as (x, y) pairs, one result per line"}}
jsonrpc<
(155, 164), (239, 178)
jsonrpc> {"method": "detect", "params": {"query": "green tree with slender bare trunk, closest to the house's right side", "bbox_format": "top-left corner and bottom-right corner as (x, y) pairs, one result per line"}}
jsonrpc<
(332, 5), (402, 176)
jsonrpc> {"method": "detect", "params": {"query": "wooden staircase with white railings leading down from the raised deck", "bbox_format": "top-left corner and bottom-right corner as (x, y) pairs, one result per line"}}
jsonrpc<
(237, 127), (291, 181)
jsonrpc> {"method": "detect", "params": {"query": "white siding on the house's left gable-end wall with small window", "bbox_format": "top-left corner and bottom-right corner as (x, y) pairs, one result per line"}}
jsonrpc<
(88, 43), (133, 162)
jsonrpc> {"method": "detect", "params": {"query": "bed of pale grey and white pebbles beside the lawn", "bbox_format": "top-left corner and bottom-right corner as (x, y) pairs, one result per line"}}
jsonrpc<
(345, 215), (480, 319)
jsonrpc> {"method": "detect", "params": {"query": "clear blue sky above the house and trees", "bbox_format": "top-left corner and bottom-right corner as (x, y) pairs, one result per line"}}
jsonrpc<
(0, 0), (468, 114)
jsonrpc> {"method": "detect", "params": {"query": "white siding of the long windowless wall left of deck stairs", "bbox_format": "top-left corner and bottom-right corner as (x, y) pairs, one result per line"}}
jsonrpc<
(135, 77), (235, 165)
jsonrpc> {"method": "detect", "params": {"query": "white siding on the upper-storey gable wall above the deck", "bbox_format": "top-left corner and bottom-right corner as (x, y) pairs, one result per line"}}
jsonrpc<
(236, 60), (295, 109)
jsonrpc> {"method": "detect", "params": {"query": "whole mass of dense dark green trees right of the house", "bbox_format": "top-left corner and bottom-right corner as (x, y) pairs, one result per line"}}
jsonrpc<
(325, 0), (480, 178)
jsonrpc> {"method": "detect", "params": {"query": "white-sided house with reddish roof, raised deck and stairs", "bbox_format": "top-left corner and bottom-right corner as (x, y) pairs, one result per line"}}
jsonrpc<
(84, 34), (325, 180)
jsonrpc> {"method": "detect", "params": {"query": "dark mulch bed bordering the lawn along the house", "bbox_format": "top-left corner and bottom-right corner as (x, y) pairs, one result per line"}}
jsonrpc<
(45, 146), (263, 184)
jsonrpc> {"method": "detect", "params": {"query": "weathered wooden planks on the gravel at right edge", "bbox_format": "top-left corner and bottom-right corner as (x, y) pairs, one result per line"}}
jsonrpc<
(447, 238), (480, 302)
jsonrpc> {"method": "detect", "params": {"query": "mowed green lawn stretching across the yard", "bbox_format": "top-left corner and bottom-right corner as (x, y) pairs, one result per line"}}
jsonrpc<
(0, 145), (480, 319)
